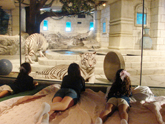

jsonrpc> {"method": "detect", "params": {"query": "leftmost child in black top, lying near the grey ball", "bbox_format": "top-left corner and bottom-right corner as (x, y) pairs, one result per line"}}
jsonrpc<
(0, 63), (36, 98)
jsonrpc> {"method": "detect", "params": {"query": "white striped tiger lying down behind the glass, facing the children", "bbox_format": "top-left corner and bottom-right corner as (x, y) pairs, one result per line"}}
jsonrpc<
(36, 52), (96, 83)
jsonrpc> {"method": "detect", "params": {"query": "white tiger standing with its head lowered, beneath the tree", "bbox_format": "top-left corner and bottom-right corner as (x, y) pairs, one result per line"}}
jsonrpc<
(25, 33), (49, 63)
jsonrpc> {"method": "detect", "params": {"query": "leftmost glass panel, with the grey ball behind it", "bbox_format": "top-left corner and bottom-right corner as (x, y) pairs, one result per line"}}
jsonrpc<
(0, 7), (20, 79)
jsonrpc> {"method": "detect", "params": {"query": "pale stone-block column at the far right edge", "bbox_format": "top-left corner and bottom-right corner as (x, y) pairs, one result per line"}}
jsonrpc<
(150, 0), (165, 50)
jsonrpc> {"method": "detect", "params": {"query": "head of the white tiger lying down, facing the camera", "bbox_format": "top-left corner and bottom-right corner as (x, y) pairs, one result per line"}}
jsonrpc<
(80, 52), (96, 68)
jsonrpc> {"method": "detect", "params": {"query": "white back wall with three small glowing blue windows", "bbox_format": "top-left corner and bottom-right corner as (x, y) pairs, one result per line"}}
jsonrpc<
(40, 15), (93, 36)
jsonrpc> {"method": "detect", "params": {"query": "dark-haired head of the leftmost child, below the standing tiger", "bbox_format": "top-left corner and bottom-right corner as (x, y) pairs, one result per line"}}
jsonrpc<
(20, 62), (31, 75)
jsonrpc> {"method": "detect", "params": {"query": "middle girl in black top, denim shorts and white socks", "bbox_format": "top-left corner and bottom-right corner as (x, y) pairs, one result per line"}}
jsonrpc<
(35, 63), (85, 124)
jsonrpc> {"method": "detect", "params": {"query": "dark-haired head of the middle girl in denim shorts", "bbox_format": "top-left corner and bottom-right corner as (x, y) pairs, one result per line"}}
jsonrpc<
(68, 63), (81, 77)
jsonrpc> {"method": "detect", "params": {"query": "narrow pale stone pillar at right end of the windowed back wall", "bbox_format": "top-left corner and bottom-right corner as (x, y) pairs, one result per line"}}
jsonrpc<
(94, 10), (101, 43)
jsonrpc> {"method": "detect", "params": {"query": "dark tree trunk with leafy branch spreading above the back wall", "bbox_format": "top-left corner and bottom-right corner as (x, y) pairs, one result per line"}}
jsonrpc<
(15, 0), (106, 35)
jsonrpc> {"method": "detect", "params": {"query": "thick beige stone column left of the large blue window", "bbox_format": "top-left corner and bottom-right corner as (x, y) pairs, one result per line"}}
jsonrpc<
(108, 0), (134, 49)
